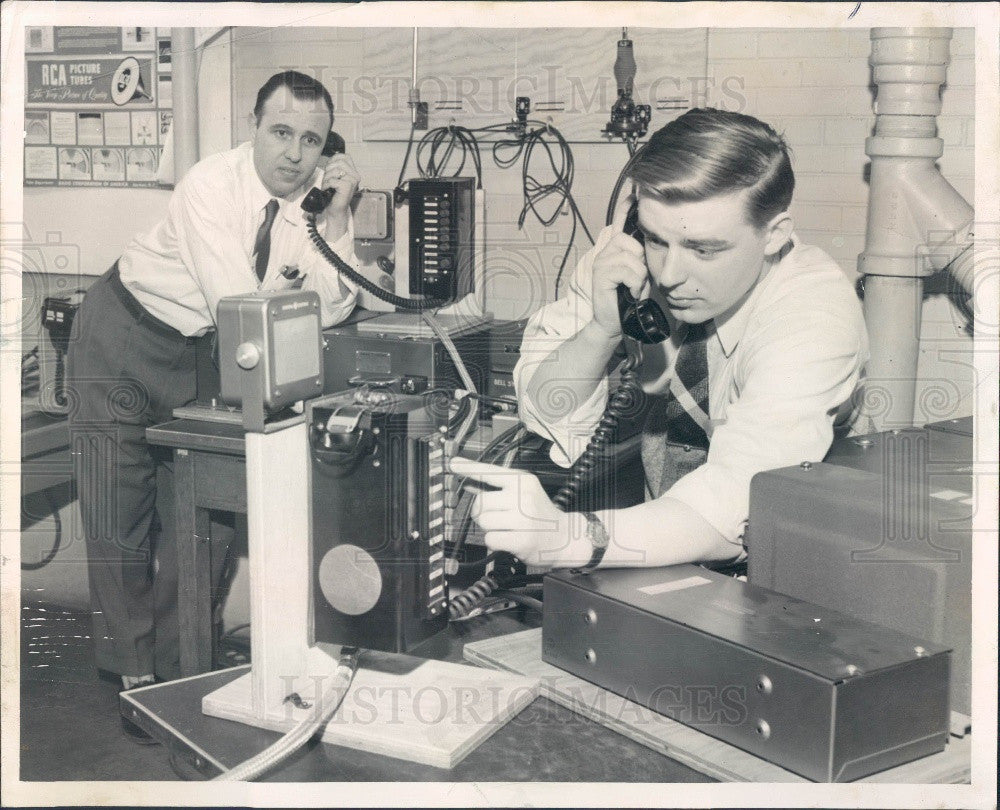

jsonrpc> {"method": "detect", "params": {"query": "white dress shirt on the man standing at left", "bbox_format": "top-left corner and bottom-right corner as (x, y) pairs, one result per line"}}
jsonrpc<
(118, 142), (357, 336)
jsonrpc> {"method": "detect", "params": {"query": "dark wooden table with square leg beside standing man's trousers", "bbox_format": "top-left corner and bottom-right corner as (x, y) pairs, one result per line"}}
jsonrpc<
(146, 419), (247, 676)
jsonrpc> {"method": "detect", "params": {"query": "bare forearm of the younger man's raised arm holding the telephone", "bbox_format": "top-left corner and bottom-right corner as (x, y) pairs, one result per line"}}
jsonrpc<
(525, 321), (620, 421)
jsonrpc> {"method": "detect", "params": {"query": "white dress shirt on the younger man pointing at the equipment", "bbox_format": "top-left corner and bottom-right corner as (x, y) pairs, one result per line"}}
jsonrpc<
(514, 221), (868, 545)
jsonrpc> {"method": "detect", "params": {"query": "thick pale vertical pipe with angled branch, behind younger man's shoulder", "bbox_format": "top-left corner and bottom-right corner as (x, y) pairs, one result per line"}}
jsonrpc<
(858, 28), (973, 430)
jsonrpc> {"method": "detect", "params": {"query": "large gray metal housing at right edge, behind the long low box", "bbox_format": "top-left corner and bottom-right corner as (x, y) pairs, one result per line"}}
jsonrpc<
(747, 420), (973, 715)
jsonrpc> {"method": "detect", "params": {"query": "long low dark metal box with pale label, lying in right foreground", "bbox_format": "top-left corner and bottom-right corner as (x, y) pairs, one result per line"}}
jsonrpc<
(542, 565), (951, 782)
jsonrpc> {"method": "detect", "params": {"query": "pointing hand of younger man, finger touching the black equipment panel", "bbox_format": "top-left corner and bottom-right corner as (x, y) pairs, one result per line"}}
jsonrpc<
(450, 458), (590, 568)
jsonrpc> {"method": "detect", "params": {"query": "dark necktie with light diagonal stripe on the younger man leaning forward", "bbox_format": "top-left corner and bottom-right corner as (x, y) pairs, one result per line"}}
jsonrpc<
(642, 322), (710, 498)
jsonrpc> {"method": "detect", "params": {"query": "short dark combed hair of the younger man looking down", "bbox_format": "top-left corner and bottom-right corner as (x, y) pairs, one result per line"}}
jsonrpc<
(628, 107), (795, 229)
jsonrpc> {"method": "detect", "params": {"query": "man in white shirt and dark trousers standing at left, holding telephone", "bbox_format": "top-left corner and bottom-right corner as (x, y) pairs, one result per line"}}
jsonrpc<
(69, 71), (359, 720)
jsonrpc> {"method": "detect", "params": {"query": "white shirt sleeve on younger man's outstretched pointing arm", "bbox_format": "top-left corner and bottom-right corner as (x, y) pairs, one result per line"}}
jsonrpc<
(662, 307), (868, 546)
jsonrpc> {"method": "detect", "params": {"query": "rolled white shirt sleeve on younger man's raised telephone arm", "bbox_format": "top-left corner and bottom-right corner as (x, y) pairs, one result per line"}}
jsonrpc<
(514, 228), (614, 467)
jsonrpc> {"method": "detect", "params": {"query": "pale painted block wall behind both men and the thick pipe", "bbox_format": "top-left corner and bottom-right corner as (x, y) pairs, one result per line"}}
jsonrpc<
(232, 28), (974, 423)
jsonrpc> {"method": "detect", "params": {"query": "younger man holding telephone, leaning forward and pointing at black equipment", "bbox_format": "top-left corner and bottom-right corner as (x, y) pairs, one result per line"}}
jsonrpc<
(452, 109), (867, 567)
